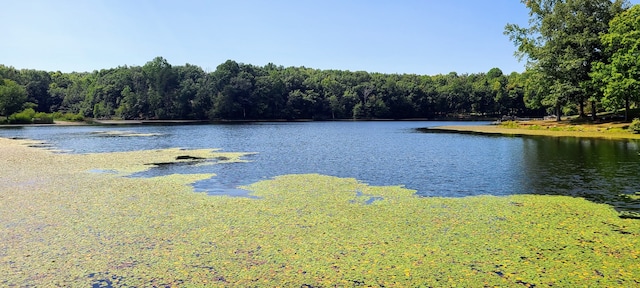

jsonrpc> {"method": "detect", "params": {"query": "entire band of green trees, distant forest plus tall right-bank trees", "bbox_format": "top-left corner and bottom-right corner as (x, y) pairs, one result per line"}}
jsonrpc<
(0, 0), (640, 120)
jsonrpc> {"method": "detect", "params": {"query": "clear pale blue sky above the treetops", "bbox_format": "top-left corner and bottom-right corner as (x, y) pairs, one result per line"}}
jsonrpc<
(0, 0), (640, 75)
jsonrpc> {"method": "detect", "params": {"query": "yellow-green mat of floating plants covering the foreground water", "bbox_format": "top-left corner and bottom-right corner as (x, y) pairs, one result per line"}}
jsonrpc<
(0, 139), (640, 287)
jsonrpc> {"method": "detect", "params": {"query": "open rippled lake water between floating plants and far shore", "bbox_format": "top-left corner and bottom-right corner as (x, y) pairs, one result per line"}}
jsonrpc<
(0, 122), (640, 211)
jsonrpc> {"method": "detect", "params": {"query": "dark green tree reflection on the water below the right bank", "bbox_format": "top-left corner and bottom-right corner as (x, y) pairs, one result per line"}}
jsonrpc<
(523, 137), (640, 210)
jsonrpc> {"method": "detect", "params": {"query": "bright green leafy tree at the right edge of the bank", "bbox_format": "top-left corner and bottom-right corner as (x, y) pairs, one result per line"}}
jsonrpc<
(591, 5), (640, 121)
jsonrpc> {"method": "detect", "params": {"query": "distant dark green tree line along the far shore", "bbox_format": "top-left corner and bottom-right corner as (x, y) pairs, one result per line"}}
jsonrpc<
(0, 57), (541, 120)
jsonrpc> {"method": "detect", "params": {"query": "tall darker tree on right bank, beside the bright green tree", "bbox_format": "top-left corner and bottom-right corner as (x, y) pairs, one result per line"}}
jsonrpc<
(505, 0), (628, 121)
